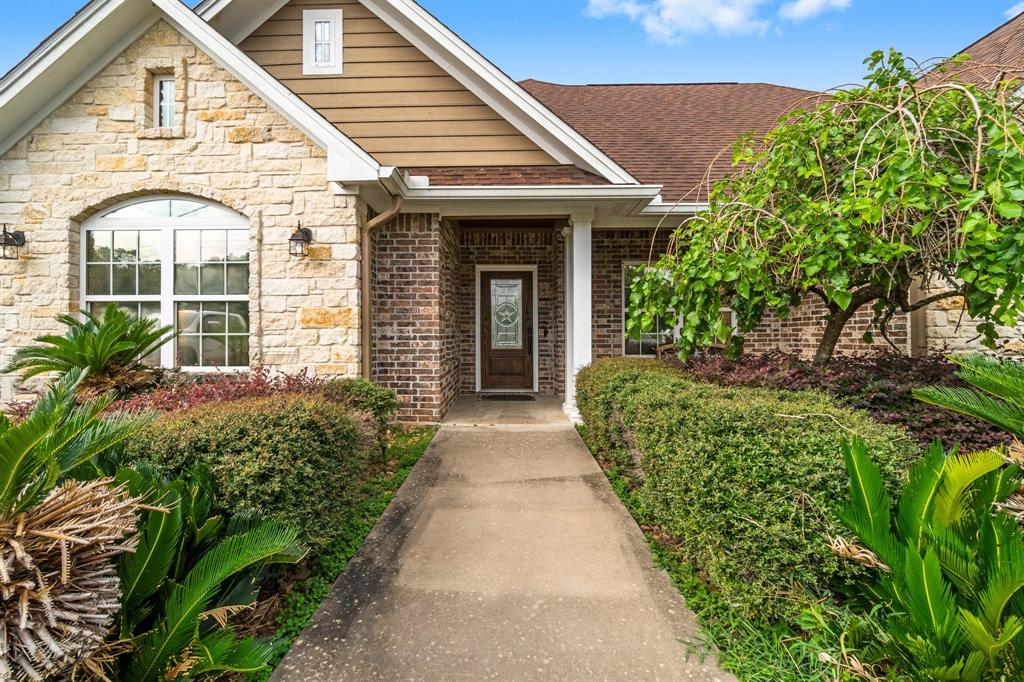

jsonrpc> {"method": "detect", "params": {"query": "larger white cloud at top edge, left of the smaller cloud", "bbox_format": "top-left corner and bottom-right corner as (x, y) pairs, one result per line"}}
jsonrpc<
(587, 0), (771, 43)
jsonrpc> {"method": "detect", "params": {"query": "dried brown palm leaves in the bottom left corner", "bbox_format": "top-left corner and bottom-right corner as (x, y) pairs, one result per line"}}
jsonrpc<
(0, 479), (139, 680)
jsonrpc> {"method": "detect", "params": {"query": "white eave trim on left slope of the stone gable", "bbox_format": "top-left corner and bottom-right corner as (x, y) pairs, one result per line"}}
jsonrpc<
(0, 0), (159, 155)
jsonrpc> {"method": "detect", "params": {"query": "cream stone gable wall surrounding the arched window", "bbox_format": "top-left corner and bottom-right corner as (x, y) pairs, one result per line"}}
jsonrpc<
(0, 22), (361, 398)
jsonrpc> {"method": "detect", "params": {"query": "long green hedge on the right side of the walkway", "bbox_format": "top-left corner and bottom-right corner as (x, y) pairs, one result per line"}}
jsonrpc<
(577, 359), (919, 620)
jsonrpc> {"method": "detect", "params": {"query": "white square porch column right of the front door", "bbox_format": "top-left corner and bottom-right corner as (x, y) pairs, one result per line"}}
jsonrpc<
(562, 213), (594, 423)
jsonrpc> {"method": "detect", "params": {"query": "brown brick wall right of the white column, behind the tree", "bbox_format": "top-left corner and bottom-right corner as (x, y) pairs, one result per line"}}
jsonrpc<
(593, 229), (909, 359)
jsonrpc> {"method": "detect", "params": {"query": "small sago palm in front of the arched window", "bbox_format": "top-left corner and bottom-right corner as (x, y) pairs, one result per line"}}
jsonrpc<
(4, 303), (175, 393)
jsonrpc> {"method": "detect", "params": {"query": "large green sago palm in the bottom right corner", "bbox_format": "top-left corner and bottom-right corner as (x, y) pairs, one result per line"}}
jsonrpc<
(833, 440), (1024, 680)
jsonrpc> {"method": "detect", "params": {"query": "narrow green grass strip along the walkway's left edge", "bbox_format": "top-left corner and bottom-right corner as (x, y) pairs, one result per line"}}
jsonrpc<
(252, 428), (437, 680)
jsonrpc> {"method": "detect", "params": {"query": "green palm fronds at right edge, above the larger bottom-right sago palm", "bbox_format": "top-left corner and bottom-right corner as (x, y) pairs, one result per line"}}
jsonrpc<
(913, 353), (1024, 438)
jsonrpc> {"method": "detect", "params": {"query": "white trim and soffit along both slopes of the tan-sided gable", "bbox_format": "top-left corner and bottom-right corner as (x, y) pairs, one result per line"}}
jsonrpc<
(196, 0), (639, 184)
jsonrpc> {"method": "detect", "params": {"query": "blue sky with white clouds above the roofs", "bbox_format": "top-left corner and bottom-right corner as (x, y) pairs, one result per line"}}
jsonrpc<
(0, 0), (1024, 89)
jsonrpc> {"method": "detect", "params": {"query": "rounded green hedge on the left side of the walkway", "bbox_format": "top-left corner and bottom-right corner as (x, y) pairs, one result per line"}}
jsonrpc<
(125, 394), (381, 550)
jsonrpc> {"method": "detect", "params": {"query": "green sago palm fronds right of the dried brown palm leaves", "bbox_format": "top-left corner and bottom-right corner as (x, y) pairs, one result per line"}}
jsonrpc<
(118, 469), (305, 682)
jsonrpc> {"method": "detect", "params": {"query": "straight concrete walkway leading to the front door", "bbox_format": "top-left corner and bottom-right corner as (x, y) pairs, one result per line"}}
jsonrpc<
(272, 398), (734, 682)
